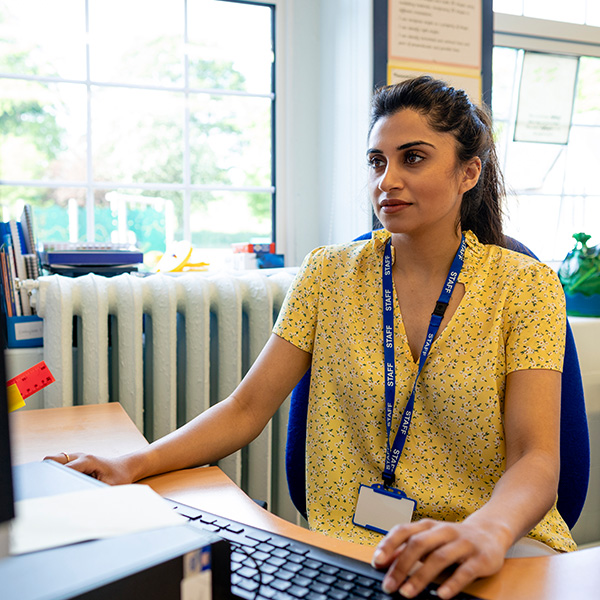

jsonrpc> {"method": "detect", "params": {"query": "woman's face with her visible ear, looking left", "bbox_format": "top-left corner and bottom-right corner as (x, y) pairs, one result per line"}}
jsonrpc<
(367, 109), (481, 235)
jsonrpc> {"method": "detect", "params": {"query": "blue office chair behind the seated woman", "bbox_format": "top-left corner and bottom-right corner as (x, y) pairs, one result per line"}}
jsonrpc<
(285, 232), (590, 529)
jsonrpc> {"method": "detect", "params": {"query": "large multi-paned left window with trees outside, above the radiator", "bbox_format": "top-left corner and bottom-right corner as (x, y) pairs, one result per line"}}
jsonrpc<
(0, 0), (275, 264)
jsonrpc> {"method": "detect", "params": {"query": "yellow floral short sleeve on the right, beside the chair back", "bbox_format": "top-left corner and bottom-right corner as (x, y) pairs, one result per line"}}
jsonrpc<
(506, 262), (566, 373)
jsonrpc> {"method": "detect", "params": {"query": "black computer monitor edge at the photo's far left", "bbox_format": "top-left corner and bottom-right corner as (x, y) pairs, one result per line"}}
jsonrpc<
(0, 313), (15, 559)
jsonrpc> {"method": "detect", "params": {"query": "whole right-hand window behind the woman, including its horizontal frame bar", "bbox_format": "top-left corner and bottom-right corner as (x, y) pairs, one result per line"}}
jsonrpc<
(492, 0), (600, 262)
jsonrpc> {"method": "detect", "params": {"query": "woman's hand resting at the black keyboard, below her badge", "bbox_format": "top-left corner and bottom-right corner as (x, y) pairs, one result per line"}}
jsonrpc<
(372, 519), (510, 600)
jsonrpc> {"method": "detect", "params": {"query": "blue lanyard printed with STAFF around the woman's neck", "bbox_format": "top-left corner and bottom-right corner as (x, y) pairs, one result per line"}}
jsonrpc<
(383, 235), (466, 487)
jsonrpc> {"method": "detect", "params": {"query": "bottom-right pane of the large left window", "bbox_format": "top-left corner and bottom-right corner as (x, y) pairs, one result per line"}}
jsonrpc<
(190, 192), (271, 249)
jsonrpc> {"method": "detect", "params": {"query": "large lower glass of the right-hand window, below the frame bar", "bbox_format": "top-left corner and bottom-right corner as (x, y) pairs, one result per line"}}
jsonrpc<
(492, 48), (600, 262)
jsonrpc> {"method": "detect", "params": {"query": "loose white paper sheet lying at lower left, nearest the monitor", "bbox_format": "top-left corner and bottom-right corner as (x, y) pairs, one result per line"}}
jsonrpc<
(10, 484), (186, 554)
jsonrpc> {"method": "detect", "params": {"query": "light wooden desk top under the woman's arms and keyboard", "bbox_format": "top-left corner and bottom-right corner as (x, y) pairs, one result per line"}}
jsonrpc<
(11, 403), (600, 600)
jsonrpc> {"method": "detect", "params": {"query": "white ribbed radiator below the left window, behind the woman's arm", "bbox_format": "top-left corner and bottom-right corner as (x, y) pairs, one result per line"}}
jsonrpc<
(34, 270), (295, 519)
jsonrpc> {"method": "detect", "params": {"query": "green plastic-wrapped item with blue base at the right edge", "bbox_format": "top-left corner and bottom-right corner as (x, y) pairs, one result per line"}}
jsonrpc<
(558, 233), (600, 317)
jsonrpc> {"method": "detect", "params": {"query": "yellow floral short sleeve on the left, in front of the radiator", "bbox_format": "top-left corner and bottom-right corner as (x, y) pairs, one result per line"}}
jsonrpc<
(273, 248), (325, 353)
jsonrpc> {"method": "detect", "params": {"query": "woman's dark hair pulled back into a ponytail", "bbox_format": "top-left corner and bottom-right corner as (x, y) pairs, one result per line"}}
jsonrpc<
(369, 76), (506, 246)
